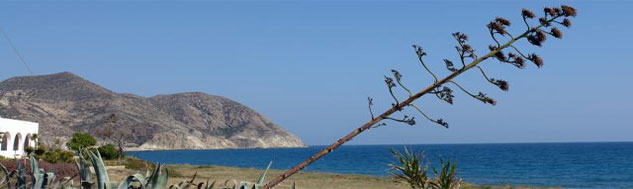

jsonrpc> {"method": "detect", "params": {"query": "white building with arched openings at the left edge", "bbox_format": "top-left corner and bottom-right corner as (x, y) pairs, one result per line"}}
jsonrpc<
(0, 117), (39, 158)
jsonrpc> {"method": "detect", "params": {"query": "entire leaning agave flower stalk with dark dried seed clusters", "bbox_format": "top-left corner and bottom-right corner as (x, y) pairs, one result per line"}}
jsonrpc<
(263, 5), (576, 189)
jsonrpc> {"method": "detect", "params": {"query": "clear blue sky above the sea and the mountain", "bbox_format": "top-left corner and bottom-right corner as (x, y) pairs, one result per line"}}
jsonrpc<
(0, 1), (633, 145)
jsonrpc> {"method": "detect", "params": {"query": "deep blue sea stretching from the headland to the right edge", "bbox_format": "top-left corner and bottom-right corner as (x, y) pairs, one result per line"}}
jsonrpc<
(127, 142), (633, 188)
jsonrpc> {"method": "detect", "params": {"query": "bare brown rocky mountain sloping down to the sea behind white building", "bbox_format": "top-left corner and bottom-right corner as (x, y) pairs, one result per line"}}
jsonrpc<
(0, 72), (305, 150)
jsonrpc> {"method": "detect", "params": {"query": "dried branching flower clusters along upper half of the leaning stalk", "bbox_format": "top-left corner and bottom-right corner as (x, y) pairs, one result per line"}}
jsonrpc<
(369, 5), (577, 128)
